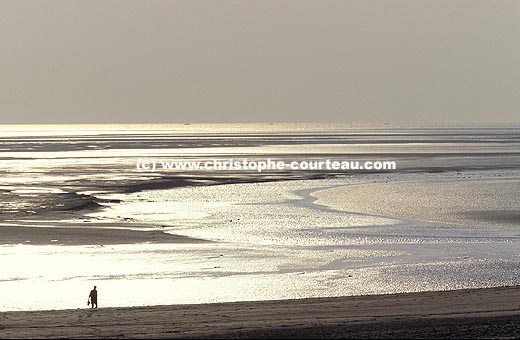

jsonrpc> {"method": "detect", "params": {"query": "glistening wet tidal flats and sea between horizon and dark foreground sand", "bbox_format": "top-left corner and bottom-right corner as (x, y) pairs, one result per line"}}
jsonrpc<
(0, 124), (520, 310)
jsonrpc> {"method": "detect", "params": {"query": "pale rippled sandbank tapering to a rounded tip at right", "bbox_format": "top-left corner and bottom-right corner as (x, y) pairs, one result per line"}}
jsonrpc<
(312, 173), (520, 228)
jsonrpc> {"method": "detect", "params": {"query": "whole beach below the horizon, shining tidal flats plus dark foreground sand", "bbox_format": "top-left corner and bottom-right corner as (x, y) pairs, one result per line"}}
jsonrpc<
(0, 125), (520, 326)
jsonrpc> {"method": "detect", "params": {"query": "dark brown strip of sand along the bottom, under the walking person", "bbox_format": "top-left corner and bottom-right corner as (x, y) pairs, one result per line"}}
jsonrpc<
(0, 286), (520, 339)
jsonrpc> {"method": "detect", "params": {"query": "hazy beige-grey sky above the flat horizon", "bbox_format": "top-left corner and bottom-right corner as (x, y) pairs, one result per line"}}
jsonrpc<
(0, 0), (520, 123)
